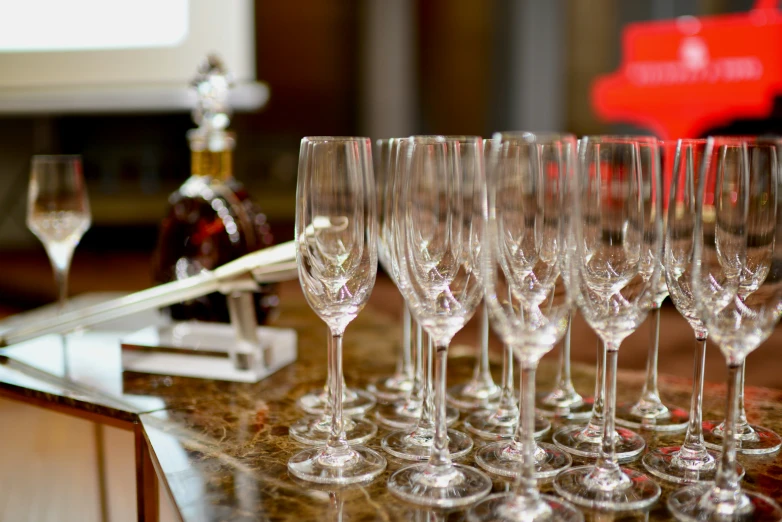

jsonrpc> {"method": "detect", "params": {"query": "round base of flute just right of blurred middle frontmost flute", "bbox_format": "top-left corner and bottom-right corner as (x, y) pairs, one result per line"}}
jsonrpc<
(554, 466), (661, 511)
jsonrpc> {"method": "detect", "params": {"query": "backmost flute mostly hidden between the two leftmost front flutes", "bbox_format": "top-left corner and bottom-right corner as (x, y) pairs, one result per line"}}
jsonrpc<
(367, 138), (415, 401)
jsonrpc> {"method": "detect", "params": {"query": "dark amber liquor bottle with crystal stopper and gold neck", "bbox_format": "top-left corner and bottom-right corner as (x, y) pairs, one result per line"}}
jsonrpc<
(153, 56), (278, 324)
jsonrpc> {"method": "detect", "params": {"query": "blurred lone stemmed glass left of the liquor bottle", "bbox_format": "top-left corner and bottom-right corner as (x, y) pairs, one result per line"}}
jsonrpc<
(27, 156), (92, 309)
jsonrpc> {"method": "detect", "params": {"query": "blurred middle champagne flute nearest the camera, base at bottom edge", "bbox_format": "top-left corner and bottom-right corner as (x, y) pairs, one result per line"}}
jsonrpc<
(468, 133), (583, 522)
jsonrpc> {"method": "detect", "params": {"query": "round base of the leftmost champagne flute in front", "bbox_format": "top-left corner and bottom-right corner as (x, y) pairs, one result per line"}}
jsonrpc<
(288, 446), (386, 484)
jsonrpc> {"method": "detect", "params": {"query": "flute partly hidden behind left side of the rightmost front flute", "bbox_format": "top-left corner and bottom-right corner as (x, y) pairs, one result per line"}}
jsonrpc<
(643, 140), (748, 483)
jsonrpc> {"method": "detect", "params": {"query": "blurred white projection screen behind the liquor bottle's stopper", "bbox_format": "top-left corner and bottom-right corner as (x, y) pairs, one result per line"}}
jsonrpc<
(0, 0), (268, 114)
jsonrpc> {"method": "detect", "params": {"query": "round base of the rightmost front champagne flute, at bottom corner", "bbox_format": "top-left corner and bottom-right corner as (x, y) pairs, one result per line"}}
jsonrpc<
(668, 484), (782, 522)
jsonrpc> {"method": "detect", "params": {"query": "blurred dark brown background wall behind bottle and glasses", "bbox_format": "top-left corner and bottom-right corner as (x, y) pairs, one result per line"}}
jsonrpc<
(0, 0), (776, 386)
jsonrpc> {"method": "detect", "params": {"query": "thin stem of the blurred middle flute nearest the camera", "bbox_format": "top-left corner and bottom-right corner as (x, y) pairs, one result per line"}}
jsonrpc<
(515, 360), (538, 498)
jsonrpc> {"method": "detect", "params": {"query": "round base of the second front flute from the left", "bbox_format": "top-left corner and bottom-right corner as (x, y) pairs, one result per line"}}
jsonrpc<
(388, 464), (492, 508)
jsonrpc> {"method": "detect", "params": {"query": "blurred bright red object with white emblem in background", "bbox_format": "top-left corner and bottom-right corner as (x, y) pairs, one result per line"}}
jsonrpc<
(592, 0), (782, 139)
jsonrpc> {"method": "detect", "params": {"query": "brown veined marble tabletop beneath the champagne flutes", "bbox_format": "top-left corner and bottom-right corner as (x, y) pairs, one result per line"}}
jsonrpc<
(0, 290), (782, 522)
